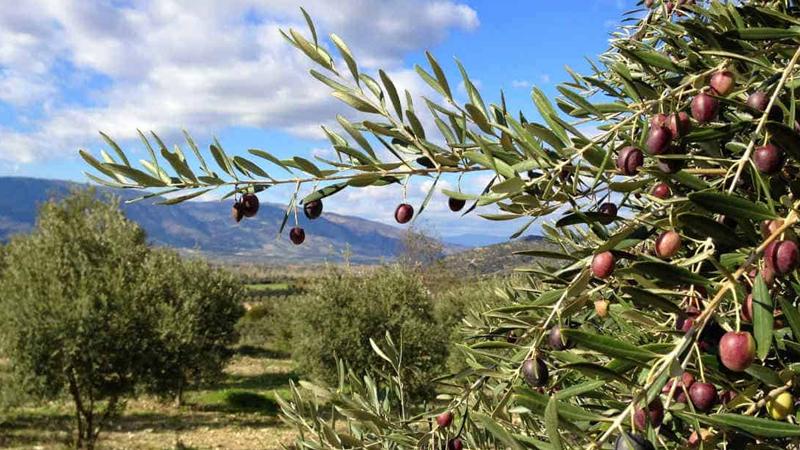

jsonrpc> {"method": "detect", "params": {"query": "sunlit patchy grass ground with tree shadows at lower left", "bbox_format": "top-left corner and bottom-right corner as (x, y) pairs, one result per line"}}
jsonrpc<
(0, 346), (295, 450)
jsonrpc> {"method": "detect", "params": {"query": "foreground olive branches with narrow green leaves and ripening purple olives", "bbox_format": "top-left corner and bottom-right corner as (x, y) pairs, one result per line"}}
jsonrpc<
(82, 0), (800, 449)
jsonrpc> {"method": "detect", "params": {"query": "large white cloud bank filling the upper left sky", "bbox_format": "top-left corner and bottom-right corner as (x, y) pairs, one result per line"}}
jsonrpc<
(0, 0), (479, 163)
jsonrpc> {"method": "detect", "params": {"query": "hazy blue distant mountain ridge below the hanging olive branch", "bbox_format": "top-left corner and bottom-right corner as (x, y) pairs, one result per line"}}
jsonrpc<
(0, 177), (418, 264)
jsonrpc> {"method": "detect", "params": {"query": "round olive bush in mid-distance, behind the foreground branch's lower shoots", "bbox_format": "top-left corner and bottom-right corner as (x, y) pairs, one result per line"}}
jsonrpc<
(292, 267), (448, 397)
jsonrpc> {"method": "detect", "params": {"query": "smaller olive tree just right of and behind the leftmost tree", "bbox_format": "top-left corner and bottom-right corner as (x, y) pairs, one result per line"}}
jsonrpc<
(139, 250), (244, 405)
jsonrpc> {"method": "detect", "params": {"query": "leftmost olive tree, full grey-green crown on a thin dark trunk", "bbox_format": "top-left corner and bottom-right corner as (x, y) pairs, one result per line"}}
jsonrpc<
(0, 191), (152, 449)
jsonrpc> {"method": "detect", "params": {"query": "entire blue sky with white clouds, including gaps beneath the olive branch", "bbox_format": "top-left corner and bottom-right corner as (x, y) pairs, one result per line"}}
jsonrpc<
(0, 0), (636, 236)
